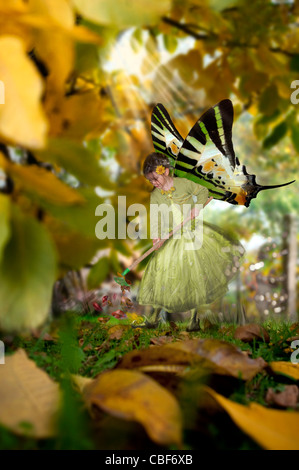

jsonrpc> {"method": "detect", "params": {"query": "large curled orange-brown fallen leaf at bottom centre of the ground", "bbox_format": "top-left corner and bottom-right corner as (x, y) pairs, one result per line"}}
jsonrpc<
(83, 370), (182, 446)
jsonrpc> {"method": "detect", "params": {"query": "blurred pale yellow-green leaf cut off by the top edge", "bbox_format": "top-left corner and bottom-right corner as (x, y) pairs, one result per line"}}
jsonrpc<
(72, 0), (171, 27)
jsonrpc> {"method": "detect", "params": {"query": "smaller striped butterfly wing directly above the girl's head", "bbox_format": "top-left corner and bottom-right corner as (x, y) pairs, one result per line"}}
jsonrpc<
(151, 103), (184, 165)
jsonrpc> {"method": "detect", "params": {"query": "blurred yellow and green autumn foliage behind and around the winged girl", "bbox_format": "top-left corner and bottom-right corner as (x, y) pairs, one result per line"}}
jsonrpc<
(0, 0), (299, 331)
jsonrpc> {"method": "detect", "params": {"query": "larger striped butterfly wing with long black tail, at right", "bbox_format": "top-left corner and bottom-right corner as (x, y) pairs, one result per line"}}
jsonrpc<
(175, 99), (293, 207)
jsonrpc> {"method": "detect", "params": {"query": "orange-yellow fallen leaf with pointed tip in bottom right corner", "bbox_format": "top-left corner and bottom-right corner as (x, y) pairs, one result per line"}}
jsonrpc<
(204, 387), (299, 450)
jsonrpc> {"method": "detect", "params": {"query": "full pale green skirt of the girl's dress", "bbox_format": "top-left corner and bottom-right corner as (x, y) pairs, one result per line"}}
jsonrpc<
(137, 222), (245, 313)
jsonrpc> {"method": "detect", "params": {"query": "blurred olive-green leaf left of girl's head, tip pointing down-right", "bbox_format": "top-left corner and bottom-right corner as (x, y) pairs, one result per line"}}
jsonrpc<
(36, 139), (115, 189)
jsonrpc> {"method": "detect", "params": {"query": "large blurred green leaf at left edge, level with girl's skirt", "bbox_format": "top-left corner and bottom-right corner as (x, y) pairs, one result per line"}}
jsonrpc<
(0, 206), (56, 332)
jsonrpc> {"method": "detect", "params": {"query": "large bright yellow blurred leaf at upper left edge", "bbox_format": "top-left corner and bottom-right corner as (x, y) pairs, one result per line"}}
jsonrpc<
(0, 36), (48, 148)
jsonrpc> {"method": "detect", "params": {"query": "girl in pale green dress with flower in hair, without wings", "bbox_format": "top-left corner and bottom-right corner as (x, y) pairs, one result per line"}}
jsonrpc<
(137, 152), (244, 331)
